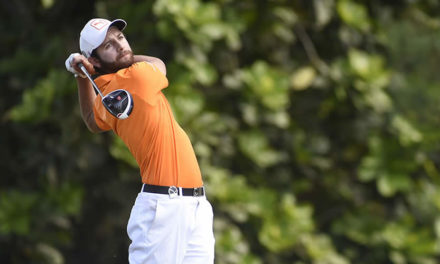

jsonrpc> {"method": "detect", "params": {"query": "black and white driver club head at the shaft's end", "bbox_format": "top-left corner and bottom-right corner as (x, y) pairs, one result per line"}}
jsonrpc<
(102, 89), (133, 119)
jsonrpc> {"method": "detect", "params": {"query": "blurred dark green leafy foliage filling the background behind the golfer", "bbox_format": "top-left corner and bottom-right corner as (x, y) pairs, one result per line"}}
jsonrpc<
(0, 0), (440, 264)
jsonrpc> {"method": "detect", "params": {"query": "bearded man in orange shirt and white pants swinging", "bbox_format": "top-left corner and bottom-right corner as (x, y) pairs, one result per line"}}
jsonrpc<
(66, 18), (214, 264)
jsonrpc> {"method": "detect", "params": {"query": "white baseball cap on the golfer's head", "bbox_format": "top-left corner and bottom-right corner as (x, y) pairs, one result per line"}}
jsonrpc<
(79, 18), (127, 58)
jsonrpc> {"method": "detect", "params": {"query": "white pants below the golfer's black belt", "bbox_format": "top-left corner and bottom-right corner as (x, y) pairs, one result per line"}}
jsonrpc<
(127, 192), (215, 264)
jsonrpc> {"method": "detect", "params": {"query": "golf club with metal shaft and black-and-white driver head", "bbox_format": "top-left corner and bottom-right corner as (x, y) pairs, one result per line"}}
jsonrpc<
(78, 63), (133, 119)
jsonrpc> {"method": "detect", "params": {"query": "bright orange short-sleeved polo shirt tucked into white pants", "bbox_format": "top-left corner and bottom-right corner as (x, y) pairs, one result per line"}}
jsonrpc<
(93, 62), (203, 188)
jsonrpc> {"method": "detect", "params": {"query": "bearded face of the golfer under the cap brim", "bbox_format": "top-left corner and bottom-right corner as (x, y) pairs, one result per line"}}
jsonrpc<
(95, 27), (134, 74)
